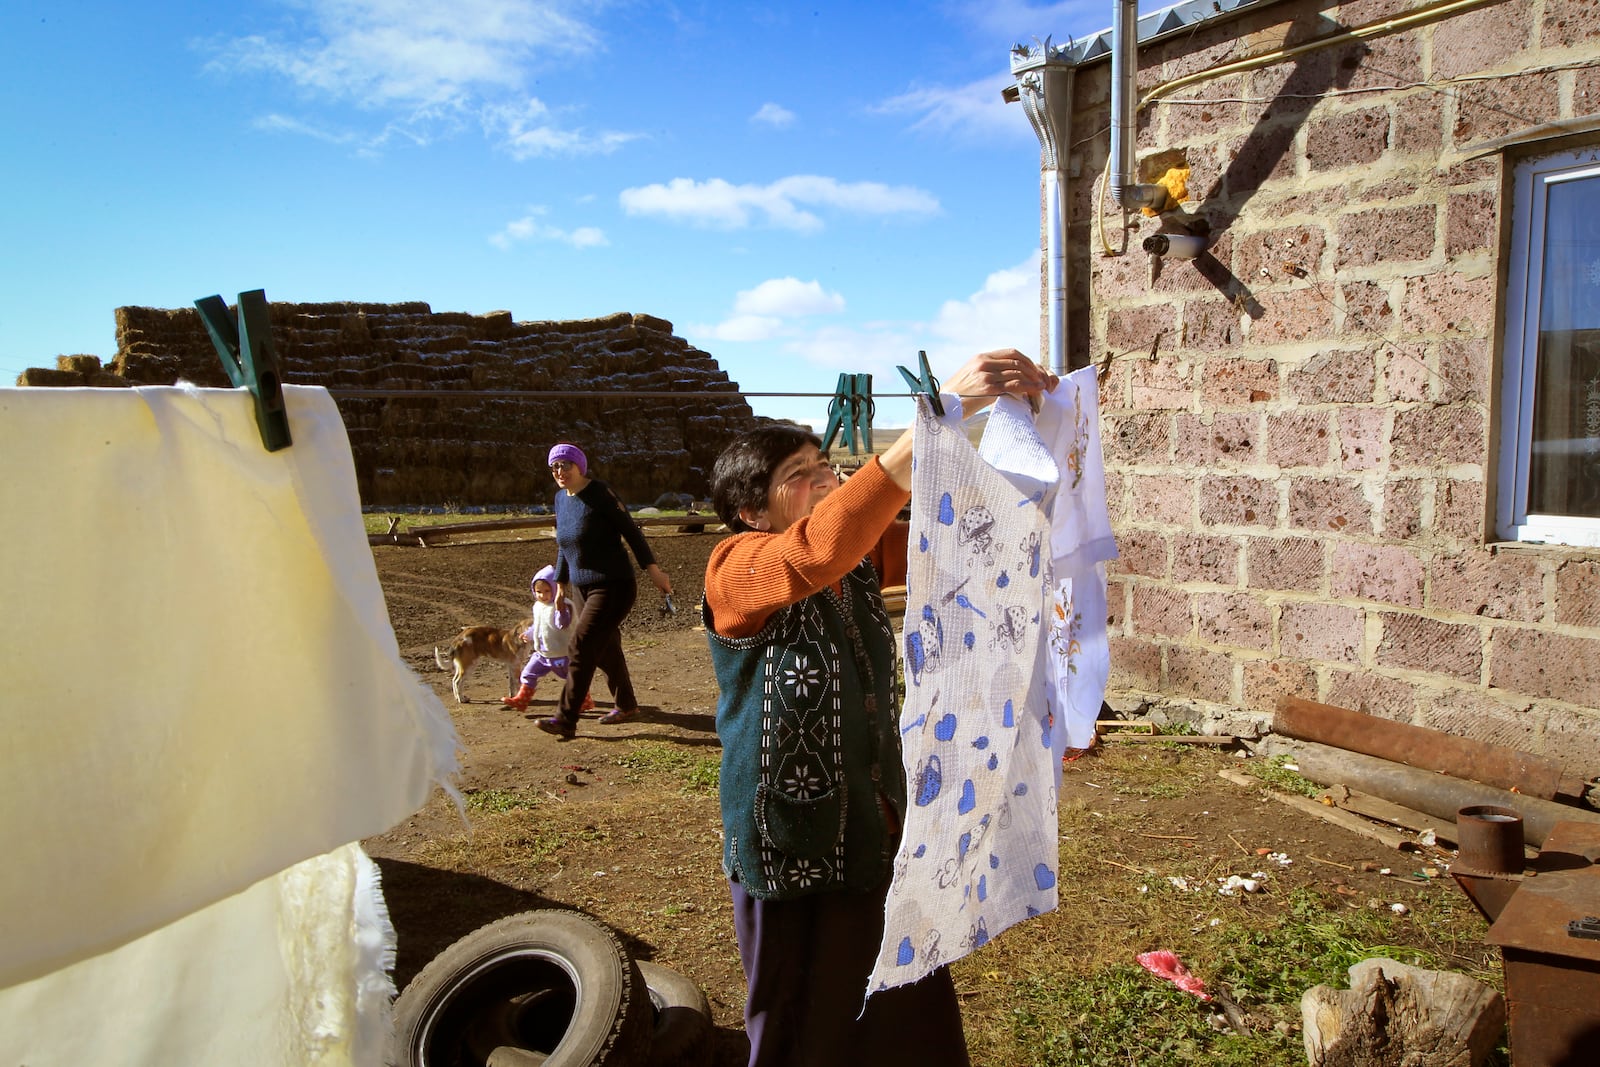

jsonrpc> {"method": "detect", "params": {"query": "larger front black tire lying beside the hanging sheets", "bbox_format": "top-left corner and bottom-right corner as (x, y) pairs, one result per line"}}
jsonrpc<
(389, 909), (654, 1067)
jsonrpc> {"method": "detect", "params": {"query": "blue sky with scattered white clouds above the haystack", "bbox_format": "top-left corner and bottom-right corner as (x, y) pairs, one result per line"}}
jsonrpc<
(0, 0), (1120, 427)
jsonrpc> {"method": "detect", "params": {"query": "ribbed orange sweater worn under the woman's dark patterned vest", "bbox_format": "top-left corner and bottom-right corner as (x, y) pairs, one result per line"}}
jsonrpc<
(706, 458), (910, 637)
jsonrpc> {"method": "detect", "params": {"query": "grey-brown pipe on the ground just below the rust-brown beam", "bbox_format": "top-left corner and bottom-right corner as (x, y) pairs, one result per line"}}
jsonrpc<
(1294, 741), (1600, 845)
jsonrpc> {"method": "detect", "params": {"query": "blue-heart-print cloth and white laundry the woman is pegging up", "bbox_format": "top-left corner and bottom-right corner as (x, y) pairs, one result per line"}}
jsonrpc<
(869, 371), (1115, 992)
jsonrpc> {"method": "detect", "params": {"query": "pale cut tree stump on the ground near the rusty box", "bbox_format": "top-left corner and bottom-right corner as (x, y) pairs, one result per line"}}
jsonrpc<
(1301, 958), (1506, 1067)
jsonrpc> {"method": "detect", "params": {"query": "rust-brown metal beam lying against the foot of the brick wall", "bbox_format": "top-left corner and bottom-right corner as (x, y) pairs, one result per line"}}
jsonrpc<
(1272, 696), (1584, 800)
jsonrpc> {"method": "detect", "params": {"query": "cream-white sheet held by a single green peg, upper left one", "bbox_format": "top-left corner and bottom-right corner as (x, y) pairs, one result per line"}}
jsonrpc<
(0, 386), (456, 987)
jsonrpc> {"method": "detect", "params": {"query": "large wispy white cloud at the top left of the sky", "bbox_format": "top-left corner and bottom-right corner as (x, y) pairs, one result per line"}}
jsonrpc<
(206, 0), (635, 160)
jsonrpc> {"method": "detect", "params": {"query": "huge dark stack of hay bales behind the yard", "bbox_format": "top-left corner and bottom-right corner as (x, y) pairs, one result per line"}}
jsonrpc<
(18, 302), (765, 506)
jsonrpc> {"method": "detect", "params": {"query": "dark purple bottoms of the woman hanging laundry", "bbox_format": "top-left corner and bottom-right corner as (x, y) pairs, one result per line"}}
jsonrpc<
(728, 881), (971, 1067)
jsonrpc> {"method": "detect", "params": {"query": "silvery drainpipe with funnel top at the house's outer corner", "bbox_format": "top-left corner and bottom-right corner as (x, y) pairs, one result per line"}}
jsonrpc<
(1018, 63), (1074, 374)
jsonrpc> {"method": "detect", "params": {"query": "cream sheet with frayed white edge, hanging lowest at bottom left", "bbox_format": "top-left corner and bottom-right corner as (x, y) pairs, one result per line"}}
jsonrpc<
(0, 845), (394, 1067)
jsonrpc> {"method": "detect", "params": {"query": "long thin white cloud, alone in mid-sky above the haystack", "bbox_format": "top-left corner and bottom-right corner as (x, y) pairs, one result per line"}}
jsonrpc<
(619, 174), (939, 230)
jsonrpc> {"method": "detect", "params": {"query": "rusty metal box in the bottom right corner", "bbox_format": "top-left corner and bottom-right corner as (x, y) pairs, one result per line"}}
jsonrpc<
(1488, 822), (1600, 1067)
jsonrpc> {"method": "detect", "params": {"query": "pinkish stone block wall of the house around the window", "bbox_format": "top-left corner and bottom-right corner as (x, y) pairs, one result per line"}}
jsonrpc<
(1069, 0), (1600, 774)
